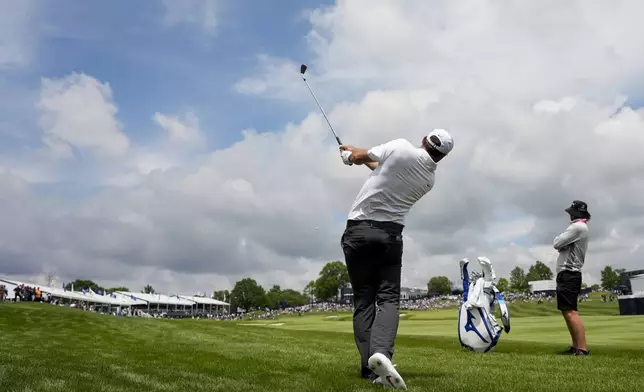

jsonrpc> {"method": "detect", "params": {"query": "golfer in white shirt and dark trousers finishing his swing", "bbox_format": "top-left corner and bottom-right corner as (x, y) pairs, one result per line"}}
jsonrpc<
(340, 129), (454, 389)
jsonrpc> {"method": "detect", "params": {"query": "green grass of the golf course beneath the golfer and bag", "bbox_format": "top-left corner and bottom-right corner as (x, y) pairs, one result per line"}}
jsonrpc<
(0, 301), (644, 392)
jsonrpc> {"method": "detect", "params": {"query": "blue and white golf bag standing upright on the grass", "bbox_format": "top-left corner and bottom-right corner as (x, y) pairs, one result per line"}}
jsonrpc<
(458, 257), (510, 353)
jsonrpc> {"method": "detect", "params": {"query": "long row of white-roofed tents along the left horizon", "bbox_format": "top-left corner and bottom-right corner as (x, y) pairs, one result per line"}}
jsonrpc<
(0, 278), (230, 314)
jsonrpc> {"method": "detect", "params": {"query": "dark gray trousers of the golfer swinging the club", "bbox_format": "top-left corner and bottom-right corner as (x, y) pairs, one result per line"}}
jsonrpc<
(342, 221), (403, 377)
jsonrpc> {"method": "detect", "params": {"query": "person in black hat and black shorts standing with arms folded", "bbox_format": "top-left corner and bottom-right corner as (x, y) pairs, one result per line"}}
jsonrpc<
(553, 200), (590, 356)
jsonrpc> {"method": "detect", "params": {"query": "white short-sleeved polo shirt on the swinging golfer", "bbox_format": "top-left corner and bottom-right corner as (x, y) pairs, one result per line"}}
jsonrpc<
(348, 139), (436, 225)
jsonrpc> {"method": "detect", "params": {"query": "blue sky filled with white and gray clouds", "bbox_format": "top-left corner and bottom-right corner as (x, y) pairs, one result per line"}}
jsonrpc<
(0, 0), (644, 293)
